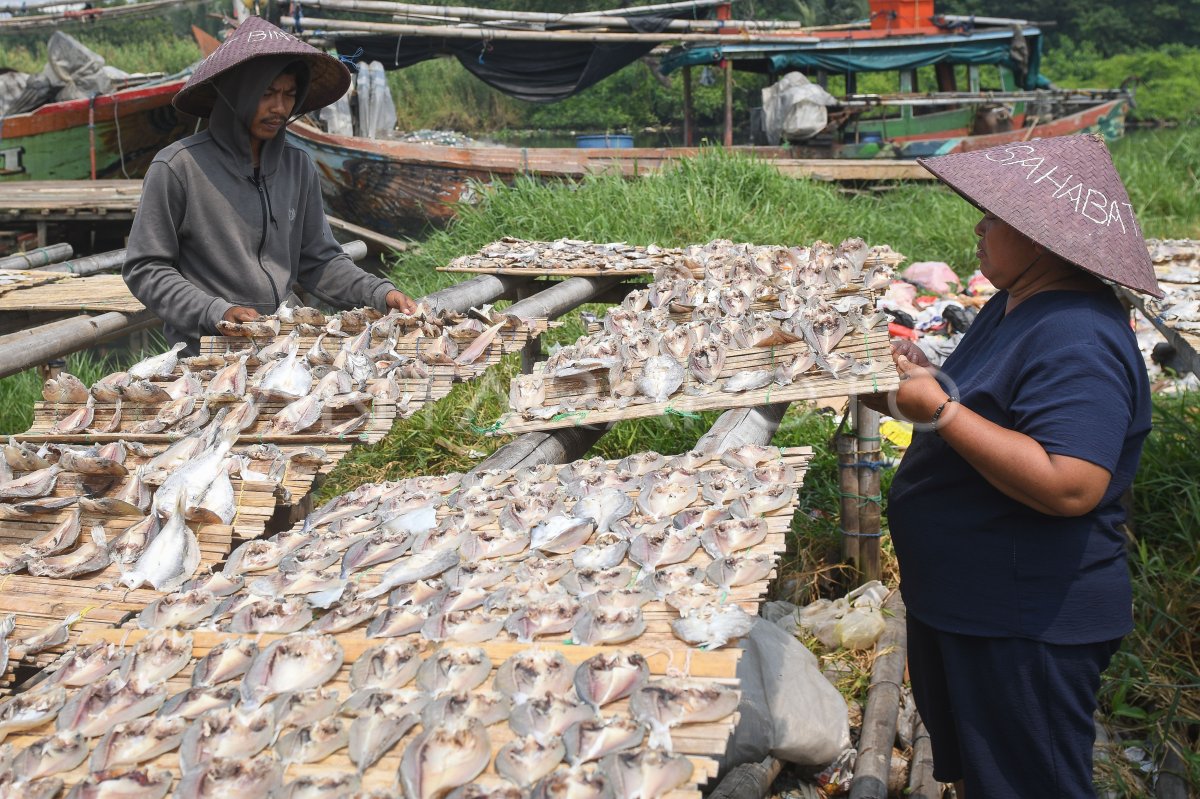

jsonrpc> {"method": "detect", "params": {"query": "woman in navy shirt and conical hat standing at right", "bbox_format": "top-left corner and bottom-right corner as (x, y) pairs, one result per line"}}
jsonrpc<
(873, 136), (1162, 799)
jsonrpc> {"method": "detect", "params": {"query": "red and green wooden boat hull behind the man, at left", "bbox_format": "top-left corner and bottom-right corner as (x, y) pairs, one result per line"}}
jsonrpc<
(0, 78), (198, 180)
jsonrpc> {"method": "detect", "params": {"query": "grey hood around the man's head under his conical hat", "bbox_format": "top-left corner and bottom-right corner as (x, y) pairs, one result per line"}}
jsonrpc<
(209, 55), (310, 176)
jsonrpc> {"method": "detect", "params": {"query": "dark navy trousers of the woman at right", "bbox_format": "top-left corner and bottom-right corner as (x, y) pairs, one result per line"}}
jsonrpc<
(907, 613), (1121, 799)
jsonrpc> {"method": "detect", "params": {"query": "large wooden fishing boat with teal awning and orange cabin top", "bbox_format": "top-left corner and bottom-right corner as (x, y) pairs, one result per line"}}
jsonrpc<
(284, 0), (1130, 234)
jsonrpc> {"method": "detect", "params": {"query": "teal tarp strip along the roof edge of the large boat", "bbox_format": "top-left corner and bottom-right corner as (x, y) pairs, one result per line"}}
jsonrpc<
(660, 29), (1042, 89)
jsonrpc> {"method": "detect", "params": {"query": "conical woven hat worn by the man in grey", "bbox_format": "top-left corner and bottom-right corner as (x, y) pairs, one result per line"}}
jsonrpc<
(172, 17), (350, 116)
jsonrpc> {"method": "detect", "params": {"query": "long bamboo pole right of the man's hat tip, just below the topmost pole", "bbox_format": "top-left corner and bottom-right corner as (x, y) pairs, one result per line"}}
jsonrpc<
(280, 17), (817, 44)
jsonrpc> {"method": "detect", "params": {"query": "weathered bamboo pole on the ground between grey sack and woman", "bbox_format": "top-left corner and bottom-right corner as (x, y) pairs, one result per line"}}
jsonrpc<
(850, 590), (908, 799)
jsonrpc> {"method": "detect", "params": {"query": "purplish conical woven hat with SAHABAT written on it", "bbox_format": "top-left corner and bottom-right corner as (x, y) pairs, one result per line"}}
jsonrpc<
(917, 133), (1163, 298)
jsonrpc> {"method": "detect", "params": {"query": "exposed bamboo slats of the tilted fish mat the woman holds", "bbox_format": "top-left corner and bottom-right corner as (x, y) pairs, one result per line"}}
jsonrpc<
(490, 325), (900, 435)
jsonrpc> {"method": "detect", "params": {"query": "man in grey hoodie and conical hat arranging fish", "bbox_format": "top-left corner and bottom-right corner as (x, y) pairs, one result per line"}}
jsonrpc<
(122, 17), (414, 354)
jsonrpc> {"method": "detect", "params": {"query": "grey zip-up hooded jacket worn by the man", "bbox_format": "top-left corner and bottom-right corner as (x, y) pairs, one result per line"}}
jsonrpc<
(122, 56), (395, 354)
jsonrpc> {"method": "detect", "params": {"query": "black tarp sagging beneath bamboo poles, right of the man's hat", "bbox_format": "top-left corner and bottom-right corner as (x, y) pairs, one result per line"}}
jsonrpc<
(337, 13), (691, 103)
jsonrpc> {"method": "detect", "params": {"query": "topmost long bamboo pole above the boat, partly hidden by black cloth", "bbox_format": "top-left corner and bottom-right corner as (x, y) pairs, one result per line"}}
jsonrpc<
(306, 0), (806, 31)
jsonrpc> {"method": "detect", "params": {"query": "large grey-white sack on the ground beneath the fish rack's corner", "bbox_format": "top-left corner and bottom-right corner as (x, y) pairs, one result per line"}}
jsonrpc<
(721, 619), (850, 774)
